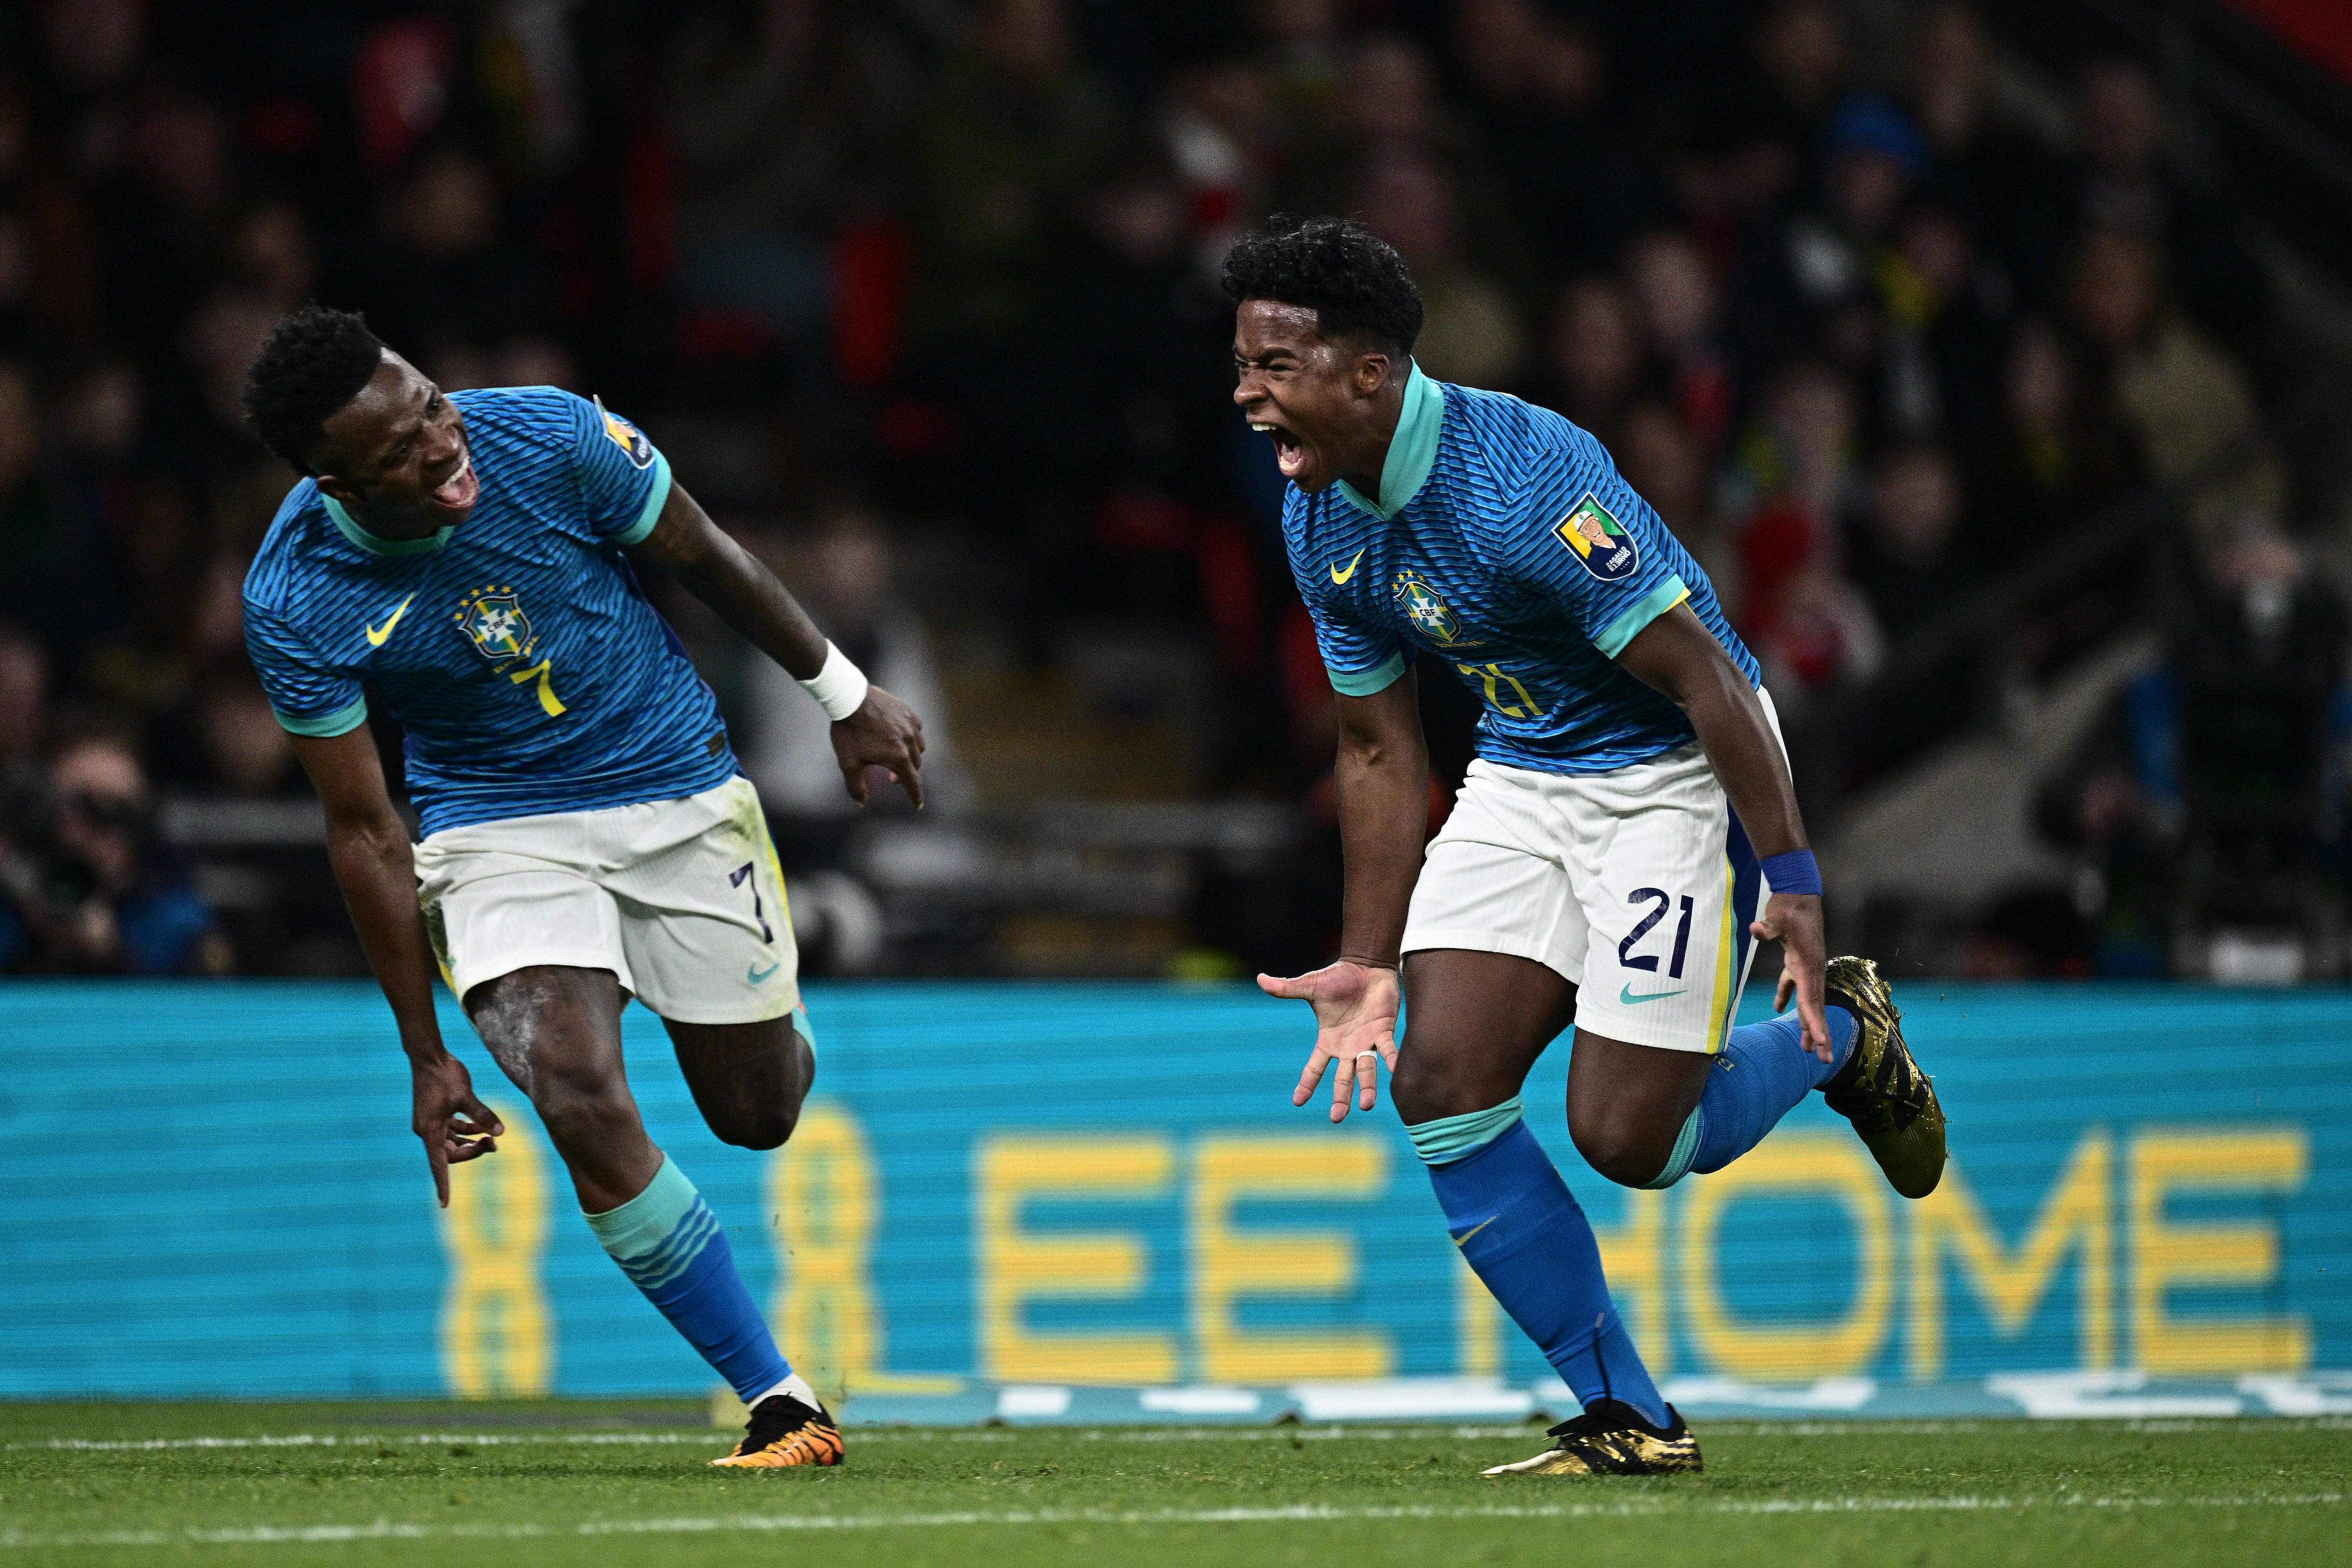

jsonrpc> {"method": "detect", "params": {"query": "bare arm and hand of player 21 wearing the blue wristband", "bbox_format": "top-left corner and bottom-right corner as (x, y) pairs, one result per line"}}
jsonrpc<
(1618, 604), (1830, 1060)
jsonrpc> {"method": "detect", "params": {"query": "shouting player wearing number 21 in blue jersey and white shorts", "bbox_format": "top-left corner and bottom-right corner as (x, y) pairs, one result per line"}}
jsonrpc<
(1225, 219), (1945, 1474)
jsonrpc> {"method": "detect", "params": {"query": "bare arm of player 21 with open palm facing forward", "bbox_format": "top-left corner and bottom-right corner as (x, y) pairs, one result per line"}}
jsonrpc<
(1258, 670), (1430, 1121)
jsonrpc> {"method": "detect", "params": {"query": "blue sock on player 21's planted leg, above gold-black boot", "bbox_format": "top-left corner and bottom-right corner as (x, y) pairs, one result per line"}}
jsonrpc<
(1406, 1102), (1668, 1427)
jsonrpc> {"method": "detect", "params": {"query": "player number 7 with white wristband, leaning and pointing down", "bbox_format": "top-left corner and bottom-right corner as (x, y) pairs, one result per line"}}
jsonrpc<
(229, 306), (922, 1467)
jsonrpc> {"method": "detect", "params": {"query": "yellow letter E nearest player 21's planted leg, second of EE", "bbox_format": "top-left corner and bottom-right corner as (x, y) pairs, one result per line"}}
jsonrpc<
(1190, 1133), (1397, 1382)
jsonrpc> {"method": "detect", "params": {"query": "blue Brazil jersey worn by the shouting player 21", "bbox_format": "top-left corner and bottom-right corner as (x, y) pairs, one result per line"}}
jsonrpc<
(1282, 367), (1757, 774)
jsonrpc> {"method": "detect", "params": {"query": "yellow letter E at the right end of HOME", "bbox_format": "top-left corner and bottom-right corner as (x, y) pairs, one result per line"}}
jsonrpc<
(2131, 1126), (2312, 1373)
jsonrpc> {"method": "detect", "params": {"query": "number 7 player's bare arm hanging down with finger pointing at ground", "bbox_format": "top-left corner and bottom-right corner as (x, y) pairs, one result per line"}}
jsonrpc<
(289, 724), (506, 1208)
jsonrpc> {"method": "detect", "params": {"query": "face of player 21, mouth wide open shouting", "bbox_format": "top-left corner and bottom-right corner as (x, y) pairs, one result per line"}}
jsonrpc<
(1232, 299), (1388, 494)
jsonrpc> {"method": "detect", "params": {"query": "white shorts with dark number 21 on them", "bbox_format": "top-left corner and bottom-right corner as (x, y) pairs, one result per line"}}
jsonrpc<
(1404, 694), (1780, 1053)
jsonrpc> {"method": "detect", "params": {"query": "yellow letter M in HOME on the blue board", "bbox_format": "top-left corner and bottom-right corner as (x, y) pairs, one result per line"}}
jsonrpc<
(1910, 1126), (2114, 1382)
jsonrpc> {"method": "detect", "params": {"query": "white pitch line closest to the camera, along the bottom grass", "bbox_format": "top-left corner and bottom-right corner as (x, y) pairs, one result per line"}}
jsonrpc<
(0, 1493), (2345, 1549)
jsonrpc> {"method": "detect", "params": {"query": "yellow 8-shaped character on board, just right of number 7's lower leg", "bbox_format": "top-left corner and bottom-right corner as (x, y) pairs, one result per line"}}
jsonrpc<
(767, 1100), (962, 1406)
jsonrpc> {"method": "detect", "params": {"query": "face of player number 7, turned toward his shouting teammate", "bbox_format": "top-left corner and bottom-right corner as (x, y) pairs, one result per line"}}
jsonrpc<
(318, 350), (482, 536)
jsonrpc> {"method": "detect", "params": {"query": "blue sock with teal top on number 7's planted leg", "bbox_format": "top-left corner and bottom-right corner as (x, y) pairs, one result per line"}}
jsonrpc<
(588, 1156), (793, 1403)
